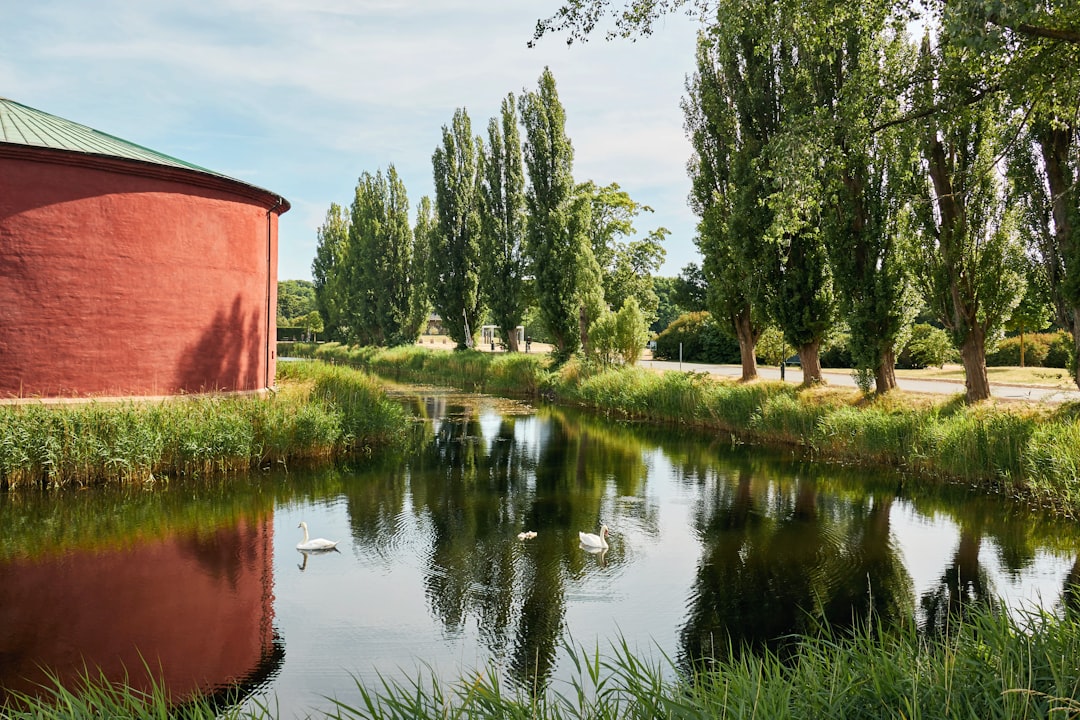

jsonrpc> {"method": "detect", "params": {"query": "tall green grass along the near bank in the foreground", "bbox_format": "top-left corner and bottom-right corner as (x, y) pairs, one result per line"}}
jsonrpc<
(8, 609), (1080, 720)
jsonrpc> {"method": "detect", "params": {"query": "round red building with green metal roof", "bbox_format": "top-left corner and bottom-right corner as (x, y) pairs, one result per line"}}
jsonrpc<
(0, 98), (289, 397)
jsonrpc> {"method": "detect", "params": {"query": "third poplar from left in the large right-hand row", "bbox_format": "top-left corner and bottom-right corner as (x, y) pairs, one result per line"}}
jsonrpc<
(788, 0), (917, 393)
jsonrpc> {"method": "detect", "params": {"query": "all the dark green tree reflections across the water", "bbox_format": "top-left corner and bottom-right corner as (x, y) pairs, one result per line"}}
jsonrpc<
(326, 395), (1080, 688)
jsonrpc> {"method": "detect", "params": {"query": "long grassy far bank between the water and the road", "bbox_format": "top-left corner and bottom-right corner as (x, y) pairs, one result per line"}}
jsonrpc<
(282, 343), (1080, 515)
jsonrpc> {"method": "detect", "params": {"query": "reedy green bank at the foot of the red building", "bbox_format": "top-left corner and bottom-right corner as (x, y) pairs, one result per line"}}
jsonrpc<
(0, 363), (407, 487)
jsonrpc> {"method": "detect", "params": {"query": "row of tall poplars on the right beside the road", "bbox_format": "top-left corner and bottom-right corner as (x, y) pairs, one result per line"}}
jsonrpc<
(538, 0), (1080, 400)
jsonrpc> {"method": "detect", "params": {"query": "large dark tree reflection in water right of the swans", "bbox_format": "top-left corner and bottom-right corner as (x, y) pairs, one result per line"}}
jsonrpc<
(679, 463), (914, 670)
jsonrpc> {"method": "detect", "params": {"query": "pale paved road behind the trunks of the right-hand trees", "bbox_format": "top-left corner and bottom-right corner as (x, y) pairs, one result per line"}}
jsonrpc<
(637, 359), (1080, 403)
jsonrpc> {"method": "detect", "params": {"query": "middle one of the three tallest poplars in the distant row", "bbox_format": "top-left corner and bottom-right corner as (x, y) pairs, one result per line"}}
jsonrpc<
(481, 94), (526, 352)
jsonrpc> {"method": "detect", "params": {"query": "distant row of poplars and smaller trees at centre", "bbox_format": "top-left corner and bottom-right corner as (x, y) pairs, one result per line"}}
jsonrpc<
(312, 69), (667, 367)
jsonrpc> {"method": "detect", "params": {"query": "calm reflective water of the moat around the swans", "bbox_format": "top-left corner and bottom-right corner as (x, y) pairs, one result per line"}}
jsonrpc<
(0, 391), (1080, 717)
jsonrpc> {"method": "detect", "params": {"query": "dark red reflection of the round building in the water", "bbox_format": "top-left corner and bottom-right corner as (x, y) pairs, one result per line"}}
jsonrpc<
(0, 517), (273, 706)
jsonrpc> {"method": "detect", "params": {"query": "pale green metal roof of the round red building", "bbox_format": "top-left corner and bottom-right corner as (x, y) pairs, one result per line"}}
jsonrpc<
(0, 97), (234, 185)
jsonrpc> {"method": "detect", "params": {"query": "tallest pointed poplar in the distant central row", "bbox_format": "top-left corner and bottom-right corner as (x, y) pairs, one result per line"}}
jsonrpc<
(521, 68), (603, 362)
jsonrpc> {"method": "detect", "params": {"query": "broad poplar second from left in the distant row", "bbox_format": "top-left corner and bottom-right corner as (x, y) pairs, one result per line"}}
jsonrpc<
(347, 165), (420, 345)
